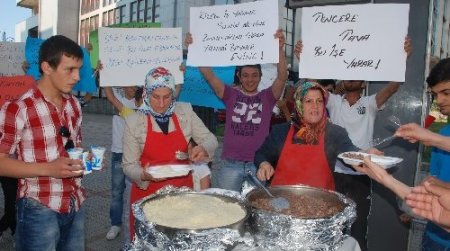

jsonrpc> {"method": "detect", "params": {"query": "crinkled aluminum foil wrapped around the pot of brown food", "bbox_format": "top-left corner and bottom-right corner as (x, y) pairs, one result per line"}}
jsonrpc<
(249, 191), (356, 251)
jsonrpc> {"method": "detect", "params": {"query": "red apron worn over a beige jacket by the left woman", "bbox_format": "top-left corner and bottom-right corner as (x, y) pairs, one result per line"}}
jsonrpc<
(130, 114), (193, 239)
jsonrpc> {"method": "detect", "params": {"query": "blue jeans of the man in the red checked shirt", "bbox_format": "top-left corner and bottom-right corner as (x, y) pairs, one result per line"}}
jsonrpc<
(16, 198), (85, 251)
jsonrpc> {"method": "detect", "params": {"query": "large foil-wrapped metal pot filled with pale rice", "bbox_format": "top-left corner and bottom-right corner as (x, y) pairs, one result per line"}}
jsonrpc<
(132, 192), (253, 250)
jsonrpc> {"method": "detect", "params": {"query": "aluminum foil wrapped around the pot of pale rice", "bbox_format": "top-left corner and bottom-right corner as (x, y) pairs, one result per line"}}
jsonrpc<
(127, 186), (254, 250)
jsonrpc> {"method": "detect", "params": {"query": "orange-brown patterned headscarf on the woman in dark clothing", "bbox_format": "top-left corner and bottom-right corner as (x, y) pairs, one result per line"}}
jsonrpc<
(294, 82), (328, 144)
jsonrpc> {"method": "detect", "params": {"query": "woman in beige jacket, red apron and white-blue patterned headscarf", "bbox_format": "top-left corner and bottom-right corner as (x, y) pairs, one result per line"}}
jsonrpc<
(122, 67), (218, 236)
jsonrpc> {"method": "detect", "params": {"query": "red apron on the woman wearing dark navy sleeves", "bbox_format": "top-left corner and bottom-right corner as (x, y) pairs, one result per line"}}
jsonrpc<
(271, 126), (334, 190)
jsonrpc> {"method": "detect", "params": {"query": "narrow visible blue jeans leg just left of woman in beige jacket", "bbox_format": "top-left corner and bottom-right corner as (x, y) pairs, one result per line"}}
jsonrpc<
(109, 152), (125, 226)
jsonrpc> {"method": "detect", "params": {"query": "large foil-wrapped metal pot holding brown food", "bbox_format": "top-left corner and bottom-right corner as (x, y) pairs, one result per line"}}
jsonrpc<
(246, 186), (356, 250)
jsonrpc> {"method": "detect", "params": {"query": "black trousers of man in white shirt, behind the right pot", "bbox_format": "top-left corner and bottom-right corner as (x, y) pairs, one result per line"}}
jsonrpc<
(334, 173), (372, 251)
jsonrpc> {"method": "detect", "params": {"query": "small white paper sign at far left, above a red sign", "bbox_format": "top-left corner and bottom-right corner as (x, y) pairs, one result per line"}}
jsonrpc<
(0, 42), (25, 76)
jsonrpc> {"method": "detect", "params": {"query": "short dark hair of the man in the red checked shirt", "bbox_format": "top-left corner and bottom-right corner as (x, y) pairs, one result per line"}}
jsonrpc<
(39, 35), (83, 74)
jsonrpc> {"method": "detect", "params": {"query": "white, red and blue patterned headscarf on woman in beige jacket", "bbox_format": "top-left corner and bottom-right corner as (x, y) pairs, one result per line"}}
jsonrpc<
(140, 67), (175, 123)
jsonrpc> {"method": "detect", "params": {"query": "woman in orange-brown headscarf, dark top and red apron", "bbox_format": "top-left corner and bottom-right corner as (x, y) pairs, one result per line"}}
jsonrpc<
(255, 82), (364, 190)
